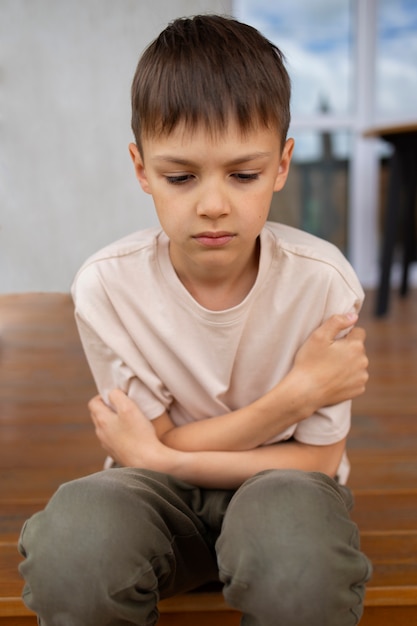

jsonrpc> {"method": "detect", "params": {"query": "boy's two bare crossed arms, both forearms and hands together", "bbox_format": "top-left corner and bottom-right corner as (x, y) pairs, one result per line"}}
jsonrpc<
(89, 315), (368, 488)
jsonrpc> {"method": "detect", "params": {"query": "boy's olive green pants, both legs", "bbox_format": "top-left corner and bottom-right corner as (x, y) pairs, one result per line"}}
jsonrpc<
(20, 468), (371, 626)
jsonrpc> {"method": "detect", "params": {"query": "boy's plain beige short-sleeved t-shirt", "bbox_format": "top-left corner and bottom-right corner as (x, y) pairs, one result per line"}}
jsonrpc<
(72, 222), (363, 483)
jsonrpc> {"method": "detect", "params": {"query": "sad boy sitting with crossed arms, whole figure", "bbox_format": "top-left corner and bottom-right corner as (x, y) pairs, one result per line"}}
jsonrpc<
(21, 15), (370, 626)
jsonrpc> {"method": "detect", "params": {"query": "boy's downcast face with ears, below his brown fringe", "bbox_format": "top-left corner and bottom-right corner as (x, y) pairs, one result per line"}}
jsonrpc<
(129, 120), (293, 274)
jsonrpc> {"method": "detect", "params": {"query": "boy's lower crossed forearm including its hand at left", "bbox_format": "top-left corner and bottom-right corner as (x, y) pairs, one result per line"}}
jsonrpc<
(89, 389), (345, 489)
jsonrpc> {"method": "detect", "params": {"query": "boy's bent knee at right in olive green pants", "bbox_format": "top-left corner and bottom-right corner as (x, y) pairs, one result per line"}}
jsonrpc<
(217, 471), (369, 625)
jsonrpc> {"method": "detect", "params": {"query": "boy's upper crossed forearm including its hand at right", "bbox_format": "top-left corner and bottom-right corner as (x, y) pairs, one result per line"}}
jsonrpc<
(160, 316), (368, 451)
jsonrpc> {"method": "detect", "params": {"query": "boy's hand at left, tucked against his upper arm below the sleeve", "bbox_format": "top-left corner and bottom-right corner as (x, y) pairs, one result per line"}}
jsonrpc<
(88, 389), (166, 469)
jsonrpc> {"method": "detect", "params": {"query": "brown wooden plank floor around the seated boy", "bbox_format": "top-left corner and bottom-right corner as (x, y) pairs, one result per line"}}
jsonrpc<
(0, 291), (417, 626)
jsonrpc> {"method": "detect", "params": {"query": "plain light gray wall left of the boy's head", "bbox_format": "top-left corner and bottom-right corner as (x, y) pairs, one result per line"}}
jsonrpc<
(0, 0), (231, 293)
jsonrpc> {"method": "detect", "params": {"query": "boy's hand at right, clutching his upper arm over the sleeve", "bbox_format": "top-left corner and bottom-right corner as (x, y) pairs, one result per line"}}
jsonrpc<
(294, 314), (369, 408)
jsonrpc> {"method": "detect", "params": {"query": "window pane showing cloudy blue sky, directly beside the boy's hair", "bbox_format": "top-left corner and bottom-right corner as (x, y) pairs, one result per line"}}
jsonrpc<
(235, 0), (354, 115)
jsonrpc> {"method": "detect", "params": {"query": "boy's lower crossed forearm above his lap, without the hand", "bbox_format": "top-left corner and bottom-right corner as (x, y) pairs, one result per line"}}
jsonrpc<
(143, 434), (345, 489)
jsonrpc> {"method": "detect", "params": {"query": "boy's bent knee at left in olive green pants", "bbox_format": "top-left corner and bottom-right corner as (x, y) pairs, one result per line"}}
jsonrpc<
(19, 470), (164, 624)
